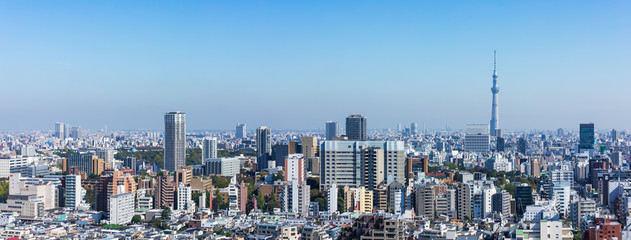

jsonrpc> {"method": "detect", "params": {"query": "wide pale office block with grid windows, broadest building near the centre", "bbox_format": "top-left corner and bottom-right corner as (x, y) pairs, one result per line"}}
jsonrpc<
(320, 141), (405, 190)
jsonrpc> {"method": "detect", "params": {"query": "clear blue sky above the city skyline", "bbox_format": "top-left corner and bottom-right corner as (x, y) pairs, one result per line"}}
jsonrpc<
(0, 1), (631, 130)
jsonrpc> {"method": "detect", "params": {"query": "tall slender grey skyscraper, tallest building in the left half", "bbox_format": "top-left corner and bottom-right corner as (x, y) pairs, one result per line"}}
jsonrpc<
(164, 112), (186, 172)
